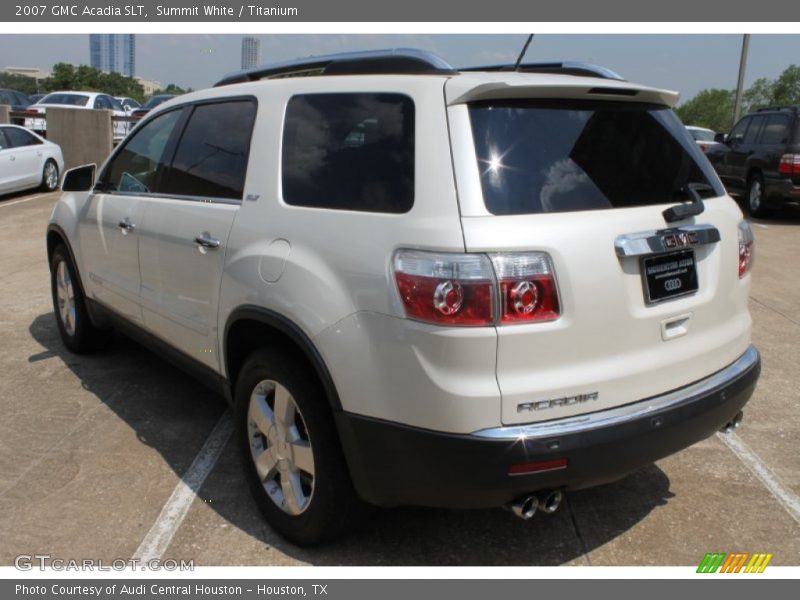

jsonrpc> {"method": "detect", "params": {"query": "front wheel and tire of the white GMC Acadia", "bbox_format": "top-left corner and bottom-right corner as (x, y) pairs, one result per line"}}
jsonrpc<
(50, 244), (111, 354)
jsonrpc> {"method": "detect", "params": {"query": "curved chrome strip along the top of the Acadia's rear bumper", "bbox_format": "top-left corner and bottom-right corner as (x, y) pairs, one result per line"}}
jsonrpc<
(471, 346), (759, 442)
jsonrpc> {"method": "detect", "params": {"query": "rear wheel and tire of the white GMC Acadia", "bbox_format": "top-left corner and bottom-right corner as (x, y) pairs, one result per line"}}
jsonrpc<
(235, 349), (363, 546)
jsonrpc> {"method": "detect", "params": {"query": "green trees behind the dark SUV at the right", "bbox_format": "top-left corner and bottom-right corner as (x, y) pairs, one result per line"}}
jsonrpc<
(675, 65), (800, 132)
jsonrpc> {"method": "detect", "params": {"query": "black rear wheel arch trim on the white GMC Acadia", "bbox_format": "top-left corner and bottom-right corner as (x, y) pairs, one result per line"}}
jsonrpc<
(222, 305), (342, 412)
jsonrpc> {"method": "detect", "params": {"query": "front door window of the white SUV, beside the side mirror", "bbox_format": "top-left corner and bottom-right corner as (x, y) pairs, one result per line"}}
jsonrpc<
(100, 110), (183, 193)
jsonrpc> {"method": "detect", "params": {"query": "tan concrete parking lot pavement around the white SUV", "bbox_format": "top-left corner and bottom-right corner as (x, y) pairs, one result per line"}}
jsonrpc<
(0, 194), (800, 565)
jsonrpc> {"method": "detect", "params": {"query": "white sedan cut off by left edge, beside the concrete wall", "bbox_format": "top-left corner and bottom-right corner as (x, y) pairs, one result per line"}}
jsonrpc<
(0, 125), (64, 194)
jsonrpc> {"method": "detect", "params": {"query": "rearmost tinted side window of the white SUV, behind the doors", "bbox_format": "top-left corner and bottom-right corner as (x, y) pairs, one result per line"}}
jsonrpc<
(281, 93), (414, 213)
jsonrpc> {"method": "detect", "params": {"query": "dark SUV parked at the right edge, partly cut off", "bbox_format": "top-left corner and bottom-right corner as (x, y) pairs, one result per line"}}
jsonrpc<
(706, 106), (800, 217)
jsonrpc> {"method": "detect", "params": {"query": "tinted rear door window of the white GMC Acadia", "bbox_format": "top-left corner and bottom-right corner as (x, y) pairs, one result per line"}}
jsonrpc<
(160, 100), (256, 200)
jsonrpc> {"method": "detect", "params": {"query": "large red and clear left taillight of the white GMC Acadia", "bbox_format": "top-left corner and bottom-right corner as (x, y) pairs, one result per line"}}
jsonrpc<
(394, 250), (559, 326)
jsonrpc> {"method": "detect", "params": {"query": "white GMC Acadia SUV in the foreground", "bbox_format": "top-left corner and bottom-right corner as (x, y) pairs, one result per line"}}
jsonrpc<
(47, 50), (760, 543)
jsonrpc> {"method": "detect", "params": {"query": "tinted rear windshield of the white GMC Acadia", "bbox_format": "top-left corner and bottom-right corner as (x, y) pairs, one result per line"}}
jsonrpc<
(469, 100), (724, 215)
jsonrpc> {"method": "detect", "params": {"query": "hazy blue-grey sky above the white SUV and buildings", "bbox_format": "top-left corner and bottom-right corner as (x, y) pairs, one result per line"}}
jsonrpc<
(0, 34), (800, 101)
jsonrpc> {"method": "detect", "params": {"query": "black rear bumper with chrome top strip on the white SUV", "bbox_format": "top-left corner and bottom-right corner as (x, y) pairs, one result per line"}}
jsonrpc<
(337, 346), (761, 508)
